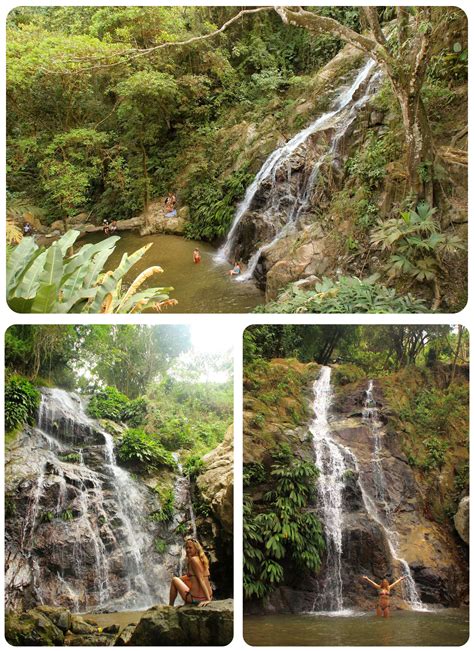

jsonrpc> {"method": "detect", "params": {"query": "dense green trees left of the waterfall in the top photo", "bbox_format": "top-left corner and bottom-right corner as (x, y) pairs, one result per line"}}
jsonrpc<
(7, 7), (359, 227)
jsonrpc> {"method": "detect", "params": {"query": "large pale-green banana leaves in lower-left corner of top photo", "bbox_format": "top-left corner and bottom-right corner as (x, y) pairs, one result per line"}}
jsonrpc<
(7, 230), (177, 314)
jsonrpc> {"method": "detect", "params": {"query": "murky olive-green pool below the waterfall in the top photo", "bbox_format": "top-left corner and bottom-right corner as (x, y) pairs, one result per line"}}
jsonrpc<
(78, 231), (263, 314)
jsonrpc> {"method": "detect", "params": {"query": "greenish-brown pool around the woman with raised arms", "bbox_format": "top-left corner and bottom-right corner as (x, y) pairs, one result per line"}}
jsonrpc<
(244, 608), (469, 646)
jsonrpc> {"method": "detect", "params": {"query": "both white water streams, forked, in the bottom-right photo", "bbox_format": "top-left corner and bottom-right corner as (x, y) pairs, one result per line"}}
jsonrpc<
(309, 366), (426, 612)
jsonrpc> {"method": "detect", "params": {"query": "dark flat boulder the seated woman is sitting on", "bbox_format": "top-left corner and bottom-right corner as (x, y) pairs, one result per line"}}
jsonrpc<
(126, 599), (233, 647)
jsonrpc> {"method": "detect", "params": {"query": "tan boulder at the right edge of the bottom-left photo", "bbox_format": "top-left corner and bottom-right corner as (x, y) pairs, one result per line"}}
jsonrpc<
(197, 427), (234, 534)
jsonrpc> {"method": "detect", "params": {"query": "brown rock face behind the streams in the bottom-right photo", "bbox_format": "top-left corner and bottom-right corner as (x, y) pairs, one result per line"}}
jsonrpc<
(244, 360), (468, 613)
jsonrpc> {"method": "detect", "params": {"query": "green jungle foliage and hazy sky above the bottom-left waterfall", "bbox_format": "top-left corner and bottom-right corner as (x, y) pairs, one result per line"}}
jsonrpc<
(5, 325), (232, 466)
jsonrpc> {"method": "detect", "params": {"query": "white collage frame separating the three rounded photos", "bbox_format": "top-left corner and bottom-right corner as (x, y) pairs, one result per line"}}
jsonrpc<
(0, 0), (474, 651)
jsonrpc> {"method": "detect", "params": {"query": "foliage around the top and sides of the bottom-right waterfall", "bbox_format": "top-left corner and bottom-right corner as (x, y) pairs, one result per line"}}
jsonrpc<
(243, 325), (469, 599)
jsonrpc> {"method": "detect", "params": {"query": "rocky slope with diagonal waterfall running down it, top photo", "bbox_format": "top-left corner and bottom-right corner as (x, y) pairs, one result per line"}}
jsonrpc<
(222, 46), (383, 299)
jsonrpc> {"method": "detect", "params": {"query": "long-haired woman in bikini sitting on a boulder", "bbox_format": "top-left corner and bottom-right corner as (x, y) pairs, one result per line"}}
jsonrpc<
(170, 538), (212, 607)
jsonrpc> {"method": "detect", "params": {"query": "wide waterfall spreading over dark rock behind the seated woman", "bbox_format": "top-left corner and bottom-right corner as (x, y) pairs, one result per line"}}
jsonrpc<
(7, 389), (182, 611)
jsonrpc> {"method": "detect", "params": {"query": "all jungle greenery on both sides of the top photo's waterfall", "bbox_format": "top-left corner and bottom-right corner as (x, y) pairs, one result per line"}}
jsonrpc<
(7, 6), (467, 313)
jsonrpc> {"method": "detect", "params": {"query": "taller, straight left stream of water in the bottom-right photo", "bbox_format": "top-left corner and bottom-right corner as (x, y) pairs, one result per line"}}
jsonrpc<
(309, 366), (347, 611)
